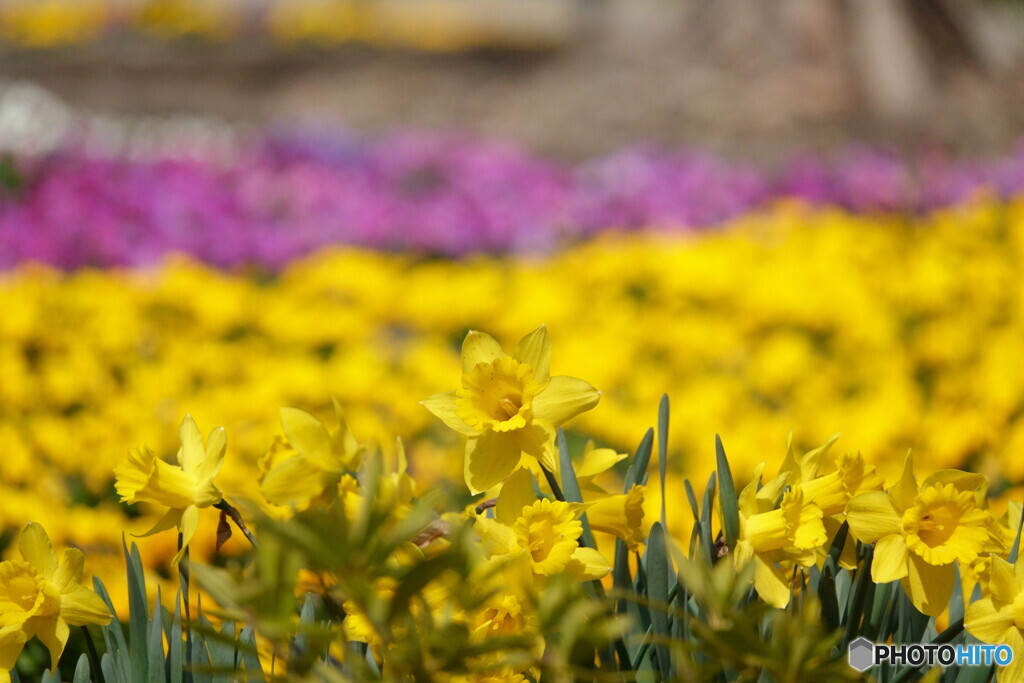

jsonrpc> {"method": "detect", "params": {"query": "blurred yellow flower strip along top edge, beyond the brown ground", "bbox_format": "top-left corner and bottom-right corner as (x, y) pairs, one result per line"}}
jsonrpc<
(0, 0), (572, 51)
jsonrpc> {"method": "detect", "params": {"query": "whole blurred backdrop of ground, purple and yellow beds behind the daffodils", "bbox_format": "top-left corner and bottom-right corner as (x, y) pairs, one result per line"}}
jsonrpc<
(0, 0), (1024, 672)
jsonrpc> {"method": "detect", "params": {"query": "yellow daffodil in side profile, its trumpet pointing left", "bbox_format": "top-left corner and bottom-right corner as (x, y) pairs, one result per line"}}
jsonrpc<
(114, 416), (227, 565)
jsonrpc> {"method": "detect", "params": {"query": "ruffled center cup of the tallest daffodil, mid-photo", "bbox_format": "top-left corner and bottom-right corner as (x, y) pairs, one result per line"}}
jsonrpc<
(456, 356), (541, 431)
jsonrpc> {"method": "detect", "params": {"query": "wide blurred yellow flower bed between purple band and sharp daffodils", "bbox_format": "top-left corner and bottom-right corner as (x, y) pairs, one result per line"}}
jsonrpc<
(0, 197), (1024, 610)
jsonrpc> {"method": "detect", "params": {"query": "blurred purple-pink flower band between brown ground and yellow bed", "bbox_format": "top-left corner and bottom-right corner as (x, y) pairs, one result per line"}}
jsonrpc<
(0, 131), (1024, 269)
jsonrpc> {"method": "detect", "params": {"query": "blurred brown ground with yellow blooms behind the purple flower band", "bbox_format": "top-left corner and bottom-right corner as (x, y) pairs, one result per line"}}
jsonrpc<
(6, 0), (1024, 157)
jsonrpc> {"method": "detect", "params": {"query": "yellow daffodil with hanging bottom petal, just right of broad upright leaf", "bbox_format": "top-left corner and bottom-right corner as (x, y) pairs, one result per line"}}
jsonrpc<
(733, 471), (826, 607)
